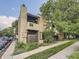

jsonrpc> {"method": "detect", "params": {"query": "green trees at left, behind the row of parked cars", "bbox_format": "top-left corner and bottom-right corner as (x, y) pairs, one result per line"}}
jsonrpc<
(0, 20), (18, 37)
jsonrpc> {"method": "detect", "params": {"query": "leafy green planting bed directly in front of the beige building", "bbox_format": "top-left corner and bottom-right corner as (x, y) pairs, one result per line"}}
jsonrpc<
(13, 42), (40, 55)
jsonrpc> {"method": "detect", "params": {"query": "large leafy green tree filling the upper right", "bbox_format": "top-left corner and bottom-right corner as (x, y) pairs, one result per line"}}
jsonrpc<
(40, 0), (79, 39)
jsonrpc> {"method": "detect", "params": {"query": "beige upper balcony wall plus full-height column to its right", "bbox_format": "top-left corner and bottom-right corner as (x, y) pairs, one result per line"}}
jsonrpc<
(27, 17), (44, 43)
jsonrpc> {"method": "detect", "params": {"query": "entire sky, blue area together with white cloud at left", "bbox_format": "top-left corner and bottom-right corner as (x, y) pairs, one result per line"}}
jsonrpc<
(0, 0), (47, 30)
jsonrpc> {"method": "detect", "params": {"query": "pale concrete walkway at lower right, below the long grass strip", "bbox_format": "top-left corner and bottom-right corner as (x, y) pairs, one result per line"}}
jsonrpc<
(48, 42), (79, 59)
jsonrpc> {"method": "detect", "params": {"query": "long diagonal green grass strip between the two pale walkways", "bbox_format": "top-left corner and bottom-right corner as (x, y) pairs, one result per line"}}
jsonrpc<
(25, 40), (76, 59)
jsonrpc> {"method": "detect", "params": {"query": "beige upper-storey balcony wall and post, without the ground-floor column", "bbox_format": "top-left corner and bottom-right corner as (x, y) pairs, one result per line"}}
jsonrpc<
(27, 17), (44, 32)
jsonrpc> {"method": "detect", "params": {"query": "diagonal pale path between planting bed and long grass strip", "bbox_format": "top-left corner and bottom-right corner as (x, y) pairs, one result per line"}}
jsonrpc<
(13, 41), (69, 59)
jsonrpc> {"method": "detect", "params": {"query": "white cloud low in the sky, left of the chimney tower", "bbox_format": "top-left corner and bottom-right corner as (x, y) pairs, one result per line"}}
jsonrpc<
(0, 16), (17, 30)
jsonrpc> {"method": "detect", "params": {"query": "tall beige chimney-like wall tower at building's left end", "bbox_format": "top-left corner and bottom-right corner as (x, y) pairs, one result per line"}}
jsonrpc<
(18, 5), (27, 43)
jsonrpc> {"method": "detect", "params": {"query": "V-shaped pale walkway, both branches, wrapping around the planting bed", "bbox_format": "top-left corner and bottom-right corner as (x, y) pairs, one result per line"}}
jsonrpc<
(1, 41), (69, 59)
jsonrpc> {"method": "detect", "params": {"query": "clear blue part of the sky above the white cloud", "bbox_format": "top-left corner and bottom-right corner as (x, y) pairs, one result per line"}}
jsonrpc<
(0, 0), (47, 17)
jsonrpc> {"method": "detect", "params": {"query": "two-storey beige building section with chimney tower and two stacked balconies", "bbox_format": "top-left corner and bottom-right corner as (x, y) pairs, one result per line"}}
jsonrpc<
(18, 4), (44, 43)
